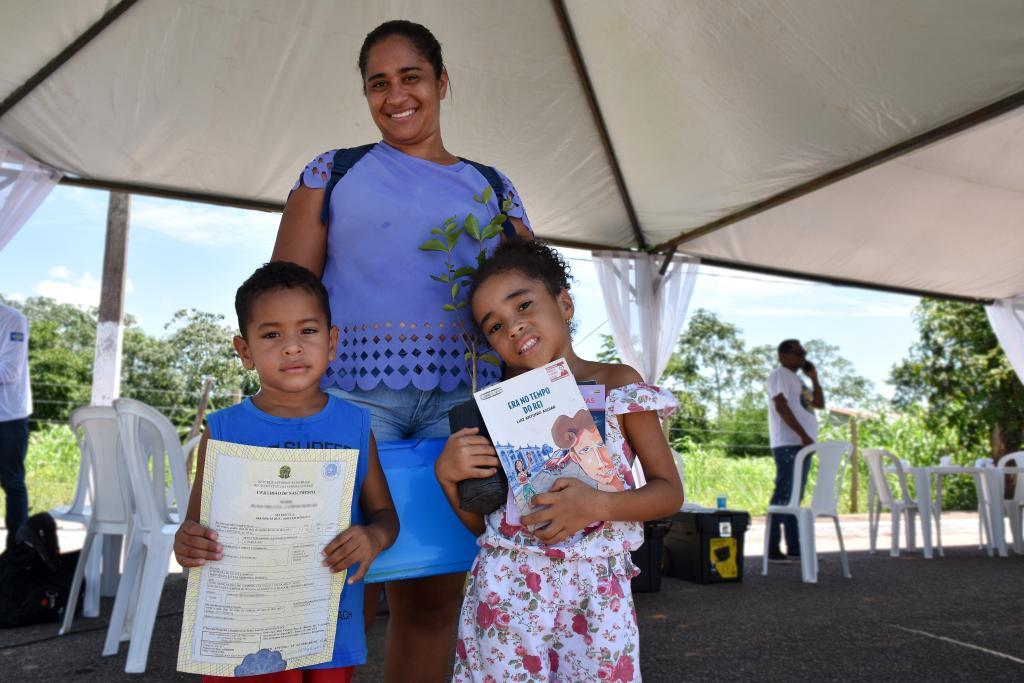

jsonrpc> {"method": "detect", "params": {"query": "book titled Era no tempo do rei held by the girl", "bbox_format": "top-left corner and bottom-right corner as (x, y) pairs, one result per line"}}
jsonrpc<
(474, 358), (629, 514)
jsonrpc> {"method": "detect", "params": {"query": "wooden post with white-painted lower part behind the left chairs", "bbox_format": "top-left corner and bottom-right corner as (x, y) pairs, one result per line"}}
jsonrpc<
(92, 193), (131, 405)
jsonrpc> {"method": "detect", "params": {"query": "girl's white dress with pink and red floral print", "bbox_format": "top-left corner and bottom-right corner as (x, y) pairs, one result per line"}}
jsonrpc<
(453, 384), (677, 683)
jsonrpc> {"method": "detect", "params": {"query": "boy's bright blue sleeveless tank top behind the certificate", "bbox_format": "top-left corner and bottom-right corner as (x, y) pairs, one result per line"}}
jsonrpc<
(207, 395), (370, 669)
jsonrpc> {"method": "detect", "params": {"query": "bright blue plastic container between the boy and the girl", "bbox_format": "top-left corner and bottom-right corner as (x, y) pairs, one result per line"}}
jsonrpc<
(366, 438), (477, 584)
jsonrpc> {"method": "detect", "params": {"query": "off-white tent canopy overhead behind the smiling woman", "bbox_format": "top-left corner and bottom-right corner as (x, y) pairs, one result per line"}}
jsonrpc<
(0, 0), (1024, 299)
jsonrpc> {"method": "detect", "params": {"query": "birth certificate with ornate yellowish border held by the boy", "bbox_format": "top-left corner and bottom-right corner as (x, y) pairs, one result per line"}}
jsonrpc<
(178, 439), (359, 676)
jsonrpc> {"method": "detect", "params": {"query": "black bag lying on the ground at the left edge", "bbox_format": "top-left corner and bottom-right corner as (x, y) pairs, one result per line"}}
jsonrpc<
(0, 512), (78, 629)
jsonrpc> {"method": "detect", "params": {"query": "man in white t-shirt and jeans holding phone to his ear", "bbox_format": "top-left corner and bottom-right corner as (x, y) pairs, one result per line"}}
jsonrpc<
(766, 339), (825, 562)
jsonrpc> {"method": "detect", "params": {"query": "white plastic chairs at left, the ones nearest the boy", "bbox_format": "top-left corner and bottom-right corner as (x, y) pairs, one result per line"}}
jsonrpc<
(103, 398), (188, 673)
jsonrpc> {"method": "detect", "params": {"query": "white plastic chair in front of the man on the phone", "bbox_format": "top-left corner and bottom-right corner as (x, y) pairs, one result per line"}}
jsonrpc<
(761, 441), (853, 584)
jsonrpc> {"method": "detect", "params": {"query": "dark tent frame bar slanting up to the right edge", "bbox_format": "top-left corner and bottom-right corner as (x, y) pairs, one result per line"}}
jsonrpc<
(650, 85), (1024, 252)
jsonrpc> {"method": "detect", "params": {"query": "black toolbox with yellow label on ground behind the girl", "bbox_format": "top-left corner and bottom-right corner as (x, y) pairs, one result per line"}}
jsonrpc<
(664, 509), (751, 584)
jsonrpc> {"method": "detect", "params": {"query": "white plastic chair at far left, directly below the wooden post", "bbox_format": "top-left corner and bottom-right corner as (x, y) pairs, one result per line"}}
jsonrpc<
(58, 405), (131, 635)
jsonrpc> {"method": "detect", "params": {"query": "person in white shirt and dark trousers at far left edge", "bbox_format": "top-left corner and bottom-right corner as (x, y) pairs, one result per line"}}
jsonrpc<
(0, 304), (32, 549)
